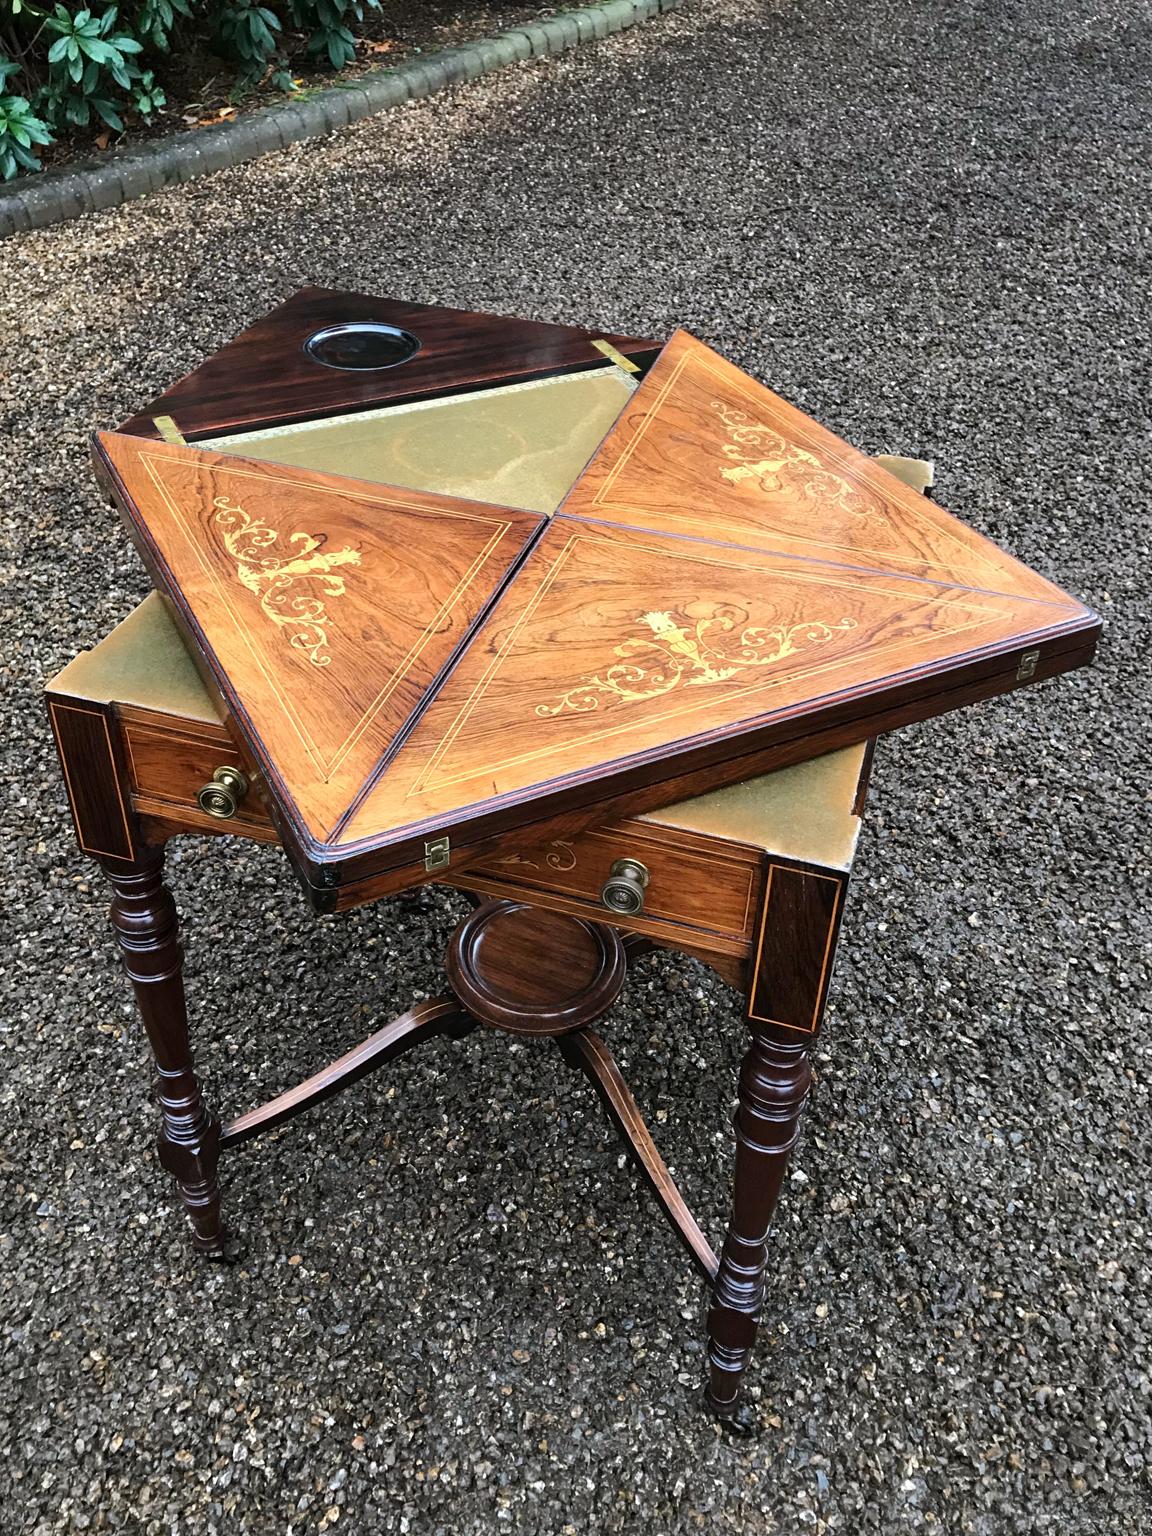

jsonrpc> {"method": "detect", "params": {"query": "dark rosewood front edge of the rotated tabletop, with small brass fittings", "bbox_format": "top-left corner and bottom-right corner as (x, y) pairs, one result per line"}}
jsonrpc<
(294, 610), (1101, 911)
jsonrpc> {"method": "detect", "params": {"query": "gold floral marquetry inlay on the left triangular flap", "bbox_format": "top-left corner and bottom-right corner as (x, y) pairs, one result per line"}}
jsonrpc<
(214, 496), (359, 667)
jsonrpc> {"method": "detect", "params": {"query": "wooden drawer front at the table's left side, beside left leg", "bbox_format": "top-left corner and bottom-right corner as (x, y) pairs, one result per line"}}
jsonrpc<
(121, 713), (272, 831)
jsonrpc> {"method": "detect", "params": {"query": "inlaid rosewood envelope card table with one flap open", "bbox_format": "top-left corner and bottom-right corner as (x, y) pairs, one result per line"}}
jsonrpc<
(48, 289), (1100, 1421)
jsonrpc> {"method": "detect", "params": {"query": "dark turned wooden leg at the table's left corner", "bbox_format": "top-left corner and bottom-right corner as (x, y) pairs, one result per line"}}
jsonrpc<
(104, 849), (224, 1255)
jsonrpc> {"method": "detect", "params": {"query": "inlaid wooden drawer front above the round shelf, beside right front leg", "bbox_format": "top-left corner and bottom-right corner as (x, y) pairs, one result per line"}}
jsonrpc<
(475, 822), (759, 938)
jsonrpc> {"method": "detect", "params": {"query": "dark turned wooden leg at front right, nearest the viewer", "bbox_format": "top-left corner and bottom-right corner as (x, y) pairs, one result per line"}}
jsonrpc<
(708, 1023), (811, 1419)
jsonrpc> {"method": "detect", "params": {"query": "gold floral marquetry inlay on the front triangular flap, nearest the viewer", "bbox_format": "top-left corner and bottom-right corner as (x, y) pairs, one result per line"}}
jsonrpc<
(536, 602), (856, 714)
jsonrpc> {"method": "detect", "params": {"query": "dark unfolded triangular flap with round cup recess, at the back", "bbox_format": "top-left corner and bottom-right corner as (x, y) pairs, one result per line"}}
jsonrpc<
(120, 287), (659, 441)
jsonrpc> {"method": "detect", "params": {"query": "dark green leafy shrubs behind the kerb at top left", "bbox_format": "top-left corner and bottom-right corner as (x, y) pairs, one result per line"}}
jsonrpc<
(0, 0), (381, 181)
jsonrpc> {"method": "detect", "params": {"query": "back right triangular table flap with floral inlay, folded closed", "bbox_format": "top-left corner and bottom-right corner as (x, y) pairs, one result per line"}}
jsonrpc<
(562, 330), (1072, 605)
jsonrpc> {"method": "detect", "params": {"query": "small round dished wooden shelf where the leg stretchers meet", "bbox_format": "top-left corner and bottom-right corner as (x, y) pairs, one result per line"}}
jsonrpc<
(444, 902), (627, 1035)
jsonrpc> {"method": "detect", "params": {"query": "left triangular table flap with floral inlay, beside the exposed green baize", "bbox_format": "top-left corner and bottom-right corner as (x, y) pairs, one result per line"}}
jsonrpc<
(95, 433), (542, 842)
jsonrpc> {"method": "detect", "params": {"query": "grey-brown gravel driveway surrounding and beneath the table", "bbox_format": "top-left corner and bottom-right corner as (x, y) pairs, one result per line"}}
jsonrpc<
(0, 0), (1152, 1536)
